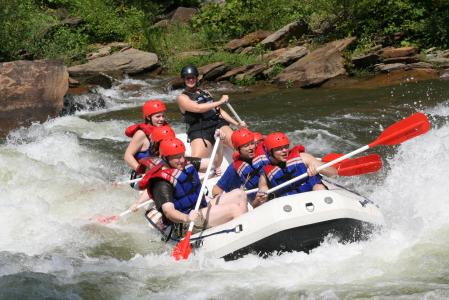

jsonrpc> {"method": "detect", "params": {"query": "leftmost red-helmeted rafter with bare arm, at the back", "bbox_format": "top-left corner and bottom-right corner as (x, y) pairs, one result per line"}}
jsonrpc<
(123, 99), (167, 172)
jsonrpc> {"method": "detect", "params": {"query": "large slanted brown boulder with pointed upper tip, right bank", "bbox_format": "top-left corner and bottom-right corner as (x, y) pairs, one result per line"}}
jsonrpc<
(274, 37), (355, 87)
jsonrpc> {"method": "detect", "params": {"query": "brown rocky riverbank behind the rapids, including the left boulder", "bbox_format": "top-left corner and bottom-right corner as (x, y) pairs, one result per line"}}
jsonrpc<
(0, 8), (449, 134)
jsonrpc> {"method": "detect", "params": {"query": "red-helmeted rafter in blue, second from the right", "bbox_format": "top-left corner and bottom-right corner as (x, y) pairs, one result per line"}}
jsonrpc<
(212, 128), (269, 198)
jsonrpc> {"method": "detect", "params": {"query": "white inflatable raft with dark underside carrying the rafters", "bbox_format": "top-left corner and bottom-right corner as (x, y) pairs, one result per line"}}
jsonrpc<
(145, 134), (384, 260)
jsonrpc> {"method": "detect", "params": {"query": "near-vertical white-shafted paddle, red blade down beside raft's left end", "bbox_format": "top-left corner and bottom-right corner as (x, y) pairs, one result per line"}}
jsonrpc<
(172, 137), (220, 260)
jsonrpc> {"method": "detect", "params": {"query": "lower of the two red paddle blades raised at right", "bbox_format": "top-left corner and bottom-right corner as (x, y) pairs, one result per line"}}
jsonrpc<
(338, 154), (382, 176)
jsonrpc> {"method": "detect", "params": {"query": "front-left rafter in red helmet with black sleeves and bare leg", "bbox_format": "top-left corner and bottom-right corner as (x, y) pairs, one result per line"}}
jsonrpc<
(133, 134), (247, 234)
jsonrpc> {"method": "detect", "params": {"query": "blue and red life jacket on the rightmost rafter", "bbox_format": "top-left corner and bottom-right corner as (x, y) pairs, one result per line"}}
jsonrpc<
(264, 151), (321, 197)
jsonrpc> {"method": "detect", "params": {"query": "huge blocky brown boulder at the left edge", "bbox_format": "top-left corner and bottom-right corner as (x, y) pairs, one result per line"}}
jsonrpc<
(0, 60), (69, 134)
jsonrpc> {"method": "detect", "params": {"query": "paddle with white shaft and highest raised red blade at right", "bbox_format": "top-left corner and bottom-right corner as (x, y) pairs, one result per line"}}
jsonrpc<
(267, 113), (430, 194)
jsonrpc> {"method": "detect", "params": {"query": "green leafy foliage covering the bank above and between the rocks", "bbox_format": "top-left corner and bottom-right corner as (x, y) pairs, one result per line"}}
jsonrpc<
(0, 0), (449, 66)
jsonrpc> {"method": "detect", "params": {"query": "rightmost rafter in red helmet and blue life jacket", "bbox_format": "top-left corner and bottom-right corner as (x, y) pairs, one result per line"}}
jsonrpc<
(253, 132), (337, 206)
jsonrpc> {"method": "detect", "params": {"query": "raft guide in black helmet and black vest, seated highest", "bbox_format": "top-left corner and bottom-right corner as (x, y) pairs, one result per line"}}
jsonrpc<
(177, 65), (246, 158)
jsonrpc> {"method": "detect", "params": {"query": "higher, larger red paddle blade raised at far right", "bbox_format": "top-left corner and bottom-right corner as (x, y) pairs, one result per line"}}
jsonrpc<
(368, 113), (430, 147)
